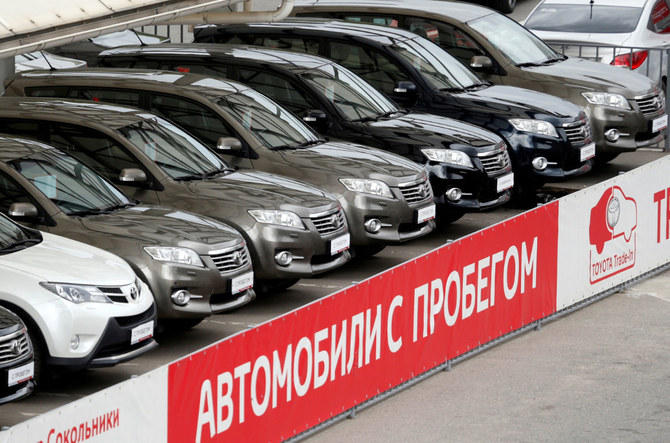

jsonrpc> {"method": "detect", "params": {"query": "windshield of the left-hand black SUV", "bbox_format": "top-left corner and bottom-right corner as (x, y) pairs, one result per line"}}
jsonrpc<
(301, 65), (400, 120)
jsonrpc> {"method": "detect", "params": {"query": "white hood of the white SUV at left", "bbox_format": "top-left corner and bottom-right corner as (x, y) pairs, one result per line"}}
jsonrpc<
(0, 232), (135, 286)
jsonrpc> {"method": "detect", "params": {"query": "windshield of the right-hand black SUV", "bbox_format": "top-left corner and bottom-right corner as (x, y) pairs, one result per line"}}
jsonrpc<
(391, 38), (483, 90)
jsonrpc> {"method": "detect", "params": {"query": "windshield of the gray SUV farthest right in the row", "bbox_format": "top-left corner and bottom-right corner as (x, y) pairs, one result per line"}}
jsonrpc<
(468, 14), (560, 65)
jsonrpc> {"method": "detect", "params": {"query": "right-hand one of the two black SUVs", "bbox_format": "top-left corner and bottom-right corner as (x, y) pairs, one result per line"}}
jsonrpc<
(194, 19), (595, 194)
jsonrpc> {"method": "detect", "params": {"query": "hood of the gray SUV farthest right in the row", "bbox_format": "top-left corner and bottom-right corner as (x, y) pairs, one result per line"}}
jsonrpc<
(523, 57), (654, 99)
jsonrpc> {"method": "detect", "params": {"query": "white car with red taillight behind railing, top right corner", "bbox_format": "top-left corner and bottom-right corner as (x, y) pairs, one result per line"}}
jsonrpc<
(523, 0), (670, 86)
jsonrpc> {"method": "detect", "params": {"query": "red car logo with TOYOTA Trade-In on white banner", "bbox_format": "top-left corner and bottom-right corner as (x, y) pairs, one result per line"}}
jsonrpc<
(589, 186), (637, 283)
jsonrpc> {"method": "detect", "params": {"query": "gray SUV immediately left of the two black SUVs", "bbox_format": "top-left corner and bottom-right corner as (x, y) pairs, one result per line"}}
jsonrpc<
(6, 69), (435, 255)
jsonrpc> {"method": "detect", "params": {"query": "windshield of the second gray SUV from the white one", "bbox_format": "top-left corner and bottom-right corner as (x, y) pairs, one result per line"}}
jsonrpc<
(119, 115), (230, 180)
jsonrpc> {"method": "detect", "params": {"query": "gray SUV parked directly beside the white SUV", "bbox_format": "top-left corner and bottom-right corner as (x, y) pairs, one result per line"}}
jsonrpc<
(0, 136), (256, 326)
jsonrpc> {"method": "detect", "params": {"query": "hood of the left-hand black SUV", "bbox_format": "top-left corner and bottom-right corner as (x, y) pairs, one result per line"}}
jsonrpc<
(367, 112), (502, 151)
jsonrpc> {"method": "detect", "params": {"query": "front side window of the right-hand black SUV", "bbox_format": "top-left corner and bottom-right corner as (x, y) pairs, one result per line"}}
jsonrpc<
(328, 42), (410, 96)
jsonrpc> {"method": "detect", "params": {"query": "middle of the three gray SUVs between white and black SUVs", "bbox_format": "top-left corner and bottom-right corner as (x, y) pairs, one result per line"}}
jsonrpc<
(0, 97), (350, 290)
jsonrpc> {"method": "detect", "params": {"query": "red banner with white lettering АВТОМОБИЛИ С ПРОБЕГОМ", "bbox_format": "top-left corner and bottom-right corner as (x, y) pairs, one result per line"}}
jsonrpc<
(168, 202), (558, 443)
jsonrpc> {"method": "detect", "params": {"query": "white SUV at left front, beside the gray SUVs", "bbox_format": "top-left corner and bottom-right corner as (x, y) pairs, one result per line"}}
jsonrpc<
(0, 216), (157, 383)
